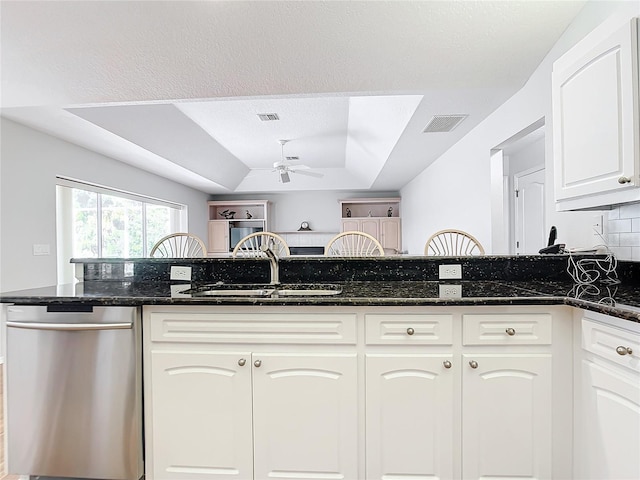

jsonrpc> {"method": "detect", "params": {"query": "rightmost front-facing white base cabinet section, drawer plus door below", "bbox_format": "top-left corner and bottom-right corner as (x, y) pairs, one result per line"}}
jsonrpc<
(461, 311), (556, 479)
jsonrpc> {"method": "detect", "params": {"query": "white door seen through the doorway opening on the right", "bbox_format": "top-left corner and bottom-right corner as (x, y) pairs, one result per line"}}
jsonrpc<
(513, 168), (549, 255)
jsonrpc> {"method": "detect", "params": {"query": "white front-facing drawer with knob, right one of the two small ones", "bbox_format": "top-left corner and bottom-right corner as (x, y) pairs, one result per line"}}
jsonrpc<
(462, 313), (551, 345)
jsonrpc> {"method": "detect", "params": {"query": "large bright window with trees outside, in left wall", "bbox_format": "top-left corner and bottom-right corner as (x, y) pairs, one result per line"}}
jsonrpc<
(56, 178), (187, 283)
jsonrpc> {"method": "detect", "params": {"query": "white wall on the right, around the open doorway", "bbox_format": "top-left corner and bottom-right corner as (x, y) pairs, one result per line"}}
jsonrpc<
(401, 1), (640, 254)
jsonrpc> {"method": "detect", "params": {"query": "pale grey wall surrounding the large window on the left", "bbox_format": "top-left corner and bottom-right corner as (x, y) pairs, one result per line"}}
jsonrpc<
(0, 118), (208, 292)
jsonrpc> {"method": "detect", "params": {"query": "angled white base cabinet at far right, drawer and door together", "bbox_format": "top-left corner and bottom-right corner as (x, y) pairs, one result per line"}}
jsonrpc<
(574, 312), (640, 480)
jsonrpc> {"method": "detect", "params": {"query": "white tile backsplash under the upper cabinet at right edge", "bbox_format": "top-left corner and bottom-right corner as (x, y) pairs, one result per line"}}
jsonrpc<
(604, 203), (640, 261)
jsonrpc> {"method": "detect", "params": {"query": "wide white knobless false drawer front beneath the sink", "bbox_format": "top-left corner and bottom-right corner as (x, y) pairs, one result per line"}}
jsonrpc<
(150, 312), (356, 345)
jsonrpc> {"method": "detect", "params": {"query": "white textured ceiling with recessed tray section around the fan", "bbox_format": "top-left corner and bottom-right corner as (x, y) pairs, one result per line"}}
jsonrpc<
(0, 0), (584, 193)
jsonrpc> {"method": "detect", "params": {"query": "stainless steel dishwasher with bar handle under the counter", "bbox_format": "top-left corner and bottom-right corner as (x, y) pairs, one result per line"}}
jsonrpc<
(6, 305), (144, 480)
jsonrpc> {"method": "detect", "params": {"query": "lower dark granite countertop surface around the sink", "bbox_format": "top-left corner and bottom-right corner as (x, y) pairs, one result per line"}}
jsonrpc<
(5, 280), (640, 323)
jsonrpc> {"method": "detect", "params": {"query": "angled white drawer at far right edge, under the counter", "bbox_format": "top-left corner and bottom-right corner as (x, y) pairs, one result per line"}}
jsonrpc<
(582, 319), (640, 372)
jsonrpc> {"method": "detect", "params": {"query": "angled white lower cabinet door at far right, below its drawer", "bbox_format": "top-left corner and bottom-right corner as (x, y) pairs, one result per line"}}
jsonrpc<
(576, 359), (640, 480)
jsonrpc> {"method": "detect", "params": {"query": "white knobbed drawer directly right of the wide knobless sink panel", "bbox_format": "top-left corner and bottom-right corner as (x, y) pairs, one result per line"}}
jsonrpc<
(365, 314), (453, 345)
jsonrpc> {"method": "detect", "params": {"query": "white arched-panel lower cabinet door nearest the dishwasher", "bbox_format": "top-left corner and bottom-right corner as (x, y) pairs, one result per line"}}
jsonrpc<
(147, 351), (253, 480)
